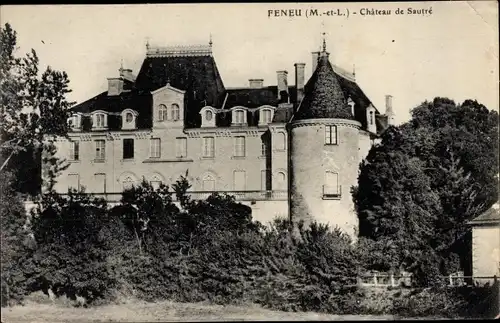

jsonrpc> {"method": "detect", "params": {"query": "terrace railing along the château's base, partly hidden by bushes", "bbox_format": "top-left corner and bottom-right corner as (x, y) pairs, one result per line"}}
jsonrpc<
(56, 190), (288, 202)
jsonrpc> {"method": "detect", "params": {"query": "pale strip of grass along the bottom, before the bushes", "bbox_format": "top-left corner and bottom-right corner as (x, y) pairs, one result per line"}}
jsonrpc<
(2, 301), (393, 323)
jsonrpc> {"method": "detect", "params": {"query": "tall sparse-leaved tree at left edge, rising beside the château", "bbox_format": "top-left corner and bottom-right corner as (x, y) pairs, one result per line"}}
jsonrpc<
(0, 23), (72, 195)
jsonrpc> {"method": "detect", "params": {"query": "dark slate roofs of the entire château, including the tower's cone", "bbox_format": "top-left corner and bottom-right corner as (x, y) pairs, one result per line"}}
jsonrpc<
(71, 44), (387, 131)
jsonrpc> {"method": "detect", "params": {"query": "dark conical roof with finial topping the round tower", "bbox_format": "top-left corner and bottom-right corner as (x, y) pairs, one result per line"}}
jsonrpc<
(293, 46), (354, 120)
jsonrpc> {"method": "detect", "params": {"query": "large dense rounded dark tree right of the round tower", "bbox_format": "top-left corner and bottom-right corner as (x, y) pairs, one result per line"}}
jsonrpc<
(353, 98), (498, 284)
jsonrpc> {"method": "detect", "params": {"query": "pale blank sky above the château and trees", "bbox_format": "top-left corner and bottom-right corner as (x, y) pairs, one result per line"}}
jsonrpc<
(0, 1), (499, 122)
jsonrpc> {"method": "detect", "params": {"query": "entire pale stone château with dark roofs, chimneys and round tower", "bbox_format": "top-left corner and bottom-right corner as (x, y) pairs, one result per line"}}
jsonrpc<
(48, 38), (394, 238)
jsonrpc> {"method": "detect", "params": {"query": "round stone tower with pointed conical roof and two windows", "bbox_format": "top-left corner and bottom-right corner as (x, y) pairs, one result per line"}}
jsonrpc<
(288, 46), (361, 238)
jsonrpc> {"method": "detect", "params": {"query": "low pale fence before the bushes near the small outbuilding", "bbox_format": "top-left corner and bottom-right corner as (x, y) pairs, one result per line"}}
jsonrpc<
(358, 273), (498, 287)
